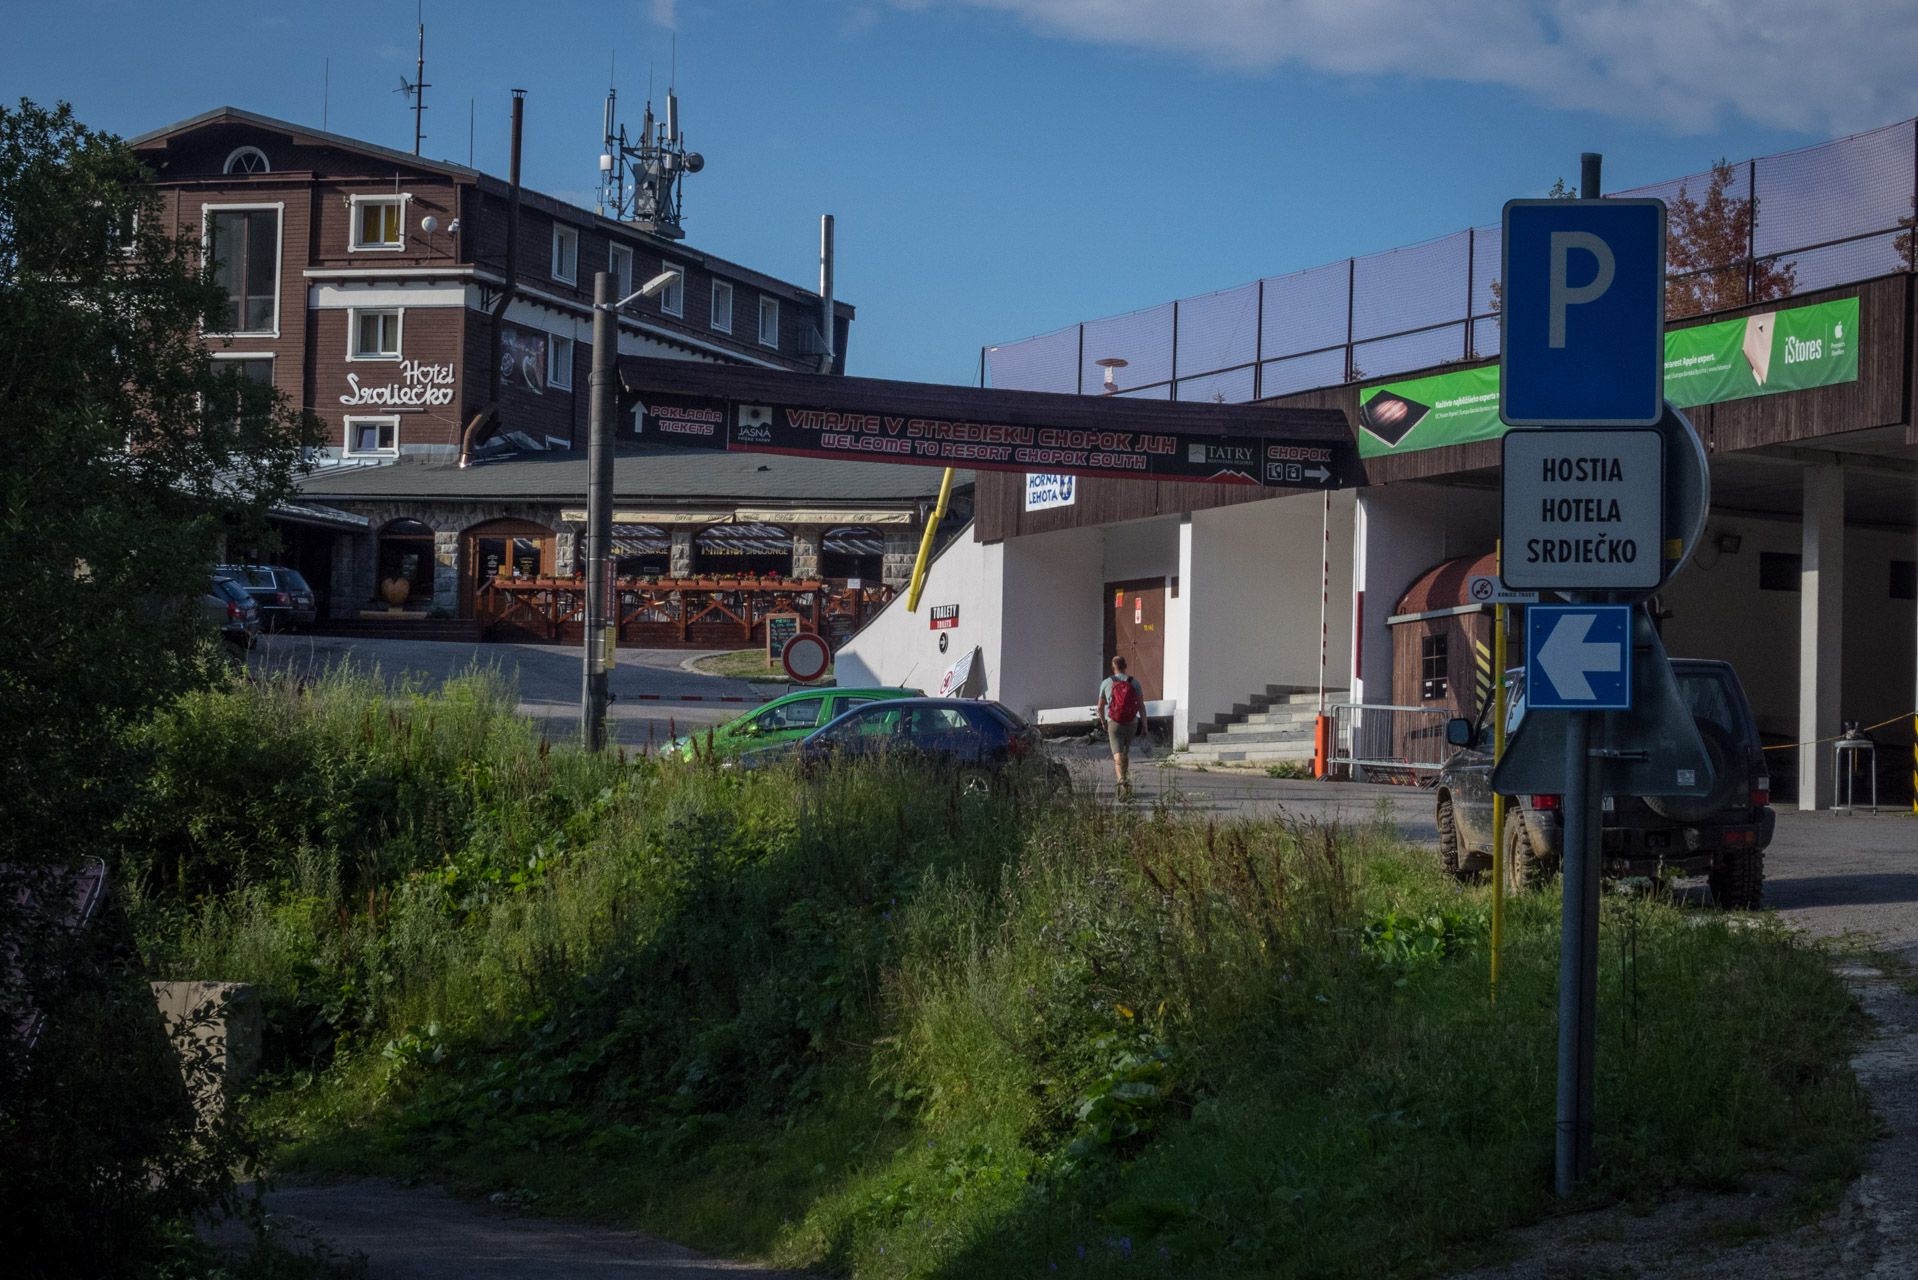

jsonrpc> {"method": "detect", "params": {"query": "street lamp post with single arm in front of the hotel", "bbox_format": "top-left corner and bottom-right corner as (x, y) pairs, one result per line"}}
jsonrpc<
(579, 271), (679, 750)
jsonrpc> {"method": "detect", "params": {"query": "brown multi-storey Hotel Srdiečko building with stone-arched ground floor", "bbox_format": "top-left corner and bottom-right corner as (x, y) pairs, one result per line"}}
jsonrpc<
(132, 107), (955, 641)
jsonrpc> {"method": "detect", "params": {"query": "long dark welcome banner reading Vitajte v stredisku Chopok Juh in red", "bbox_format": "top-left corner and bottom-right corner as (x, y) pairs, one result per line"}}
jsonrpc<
(633, 393), (1352, 489)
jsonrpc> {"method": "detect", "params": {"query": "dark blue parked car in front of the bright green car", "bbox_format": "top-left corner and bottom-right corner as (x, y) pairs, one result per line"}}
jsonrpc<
(738, 699), (1066, 791)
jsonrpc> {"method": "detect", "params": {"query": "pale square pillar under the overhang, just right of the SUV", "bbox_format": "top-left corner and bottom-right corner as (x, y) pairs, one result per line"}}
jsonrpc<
(1797, 466), (1845, 810)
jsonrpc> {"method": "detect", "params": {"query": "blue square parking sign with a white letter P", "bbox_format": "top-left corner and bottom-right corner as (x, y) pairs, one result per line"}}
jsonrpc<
(1498, 200), (1665, 426)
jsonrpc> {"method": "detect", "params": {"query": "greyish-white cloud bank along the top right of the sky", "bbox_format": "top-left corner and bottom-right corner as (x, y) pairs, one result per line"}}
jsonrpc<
(935, 0), (1918, 132)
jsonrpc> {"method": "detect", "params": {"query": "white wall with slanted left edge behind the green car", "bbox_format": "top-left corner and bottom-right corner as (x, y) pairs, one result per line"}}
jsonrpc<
(832, 530), (1005, 700)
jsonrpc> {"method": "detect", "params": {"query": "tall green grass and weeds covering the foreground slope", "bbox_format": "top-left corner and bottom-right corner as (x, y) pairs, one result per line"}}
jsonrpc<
(130, 677), (1870, 1276)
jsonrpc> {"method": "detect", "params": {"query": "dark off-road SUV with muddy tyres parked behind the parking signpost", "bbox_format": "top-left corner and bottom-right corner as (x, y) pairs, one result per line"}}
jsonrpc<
(1439, 658), (1776, 910)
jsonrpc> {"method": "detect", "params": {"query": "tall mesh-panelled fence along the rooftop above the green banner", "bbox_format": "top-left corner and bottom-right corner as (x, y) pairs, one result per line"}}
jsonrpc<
(986, 119), (1918, 403)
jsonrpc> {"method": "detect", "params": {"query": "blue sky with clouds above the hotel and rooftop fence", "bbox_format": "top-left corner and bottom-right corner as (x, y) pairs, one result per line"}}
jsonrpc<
(0, 0), (1918, 382)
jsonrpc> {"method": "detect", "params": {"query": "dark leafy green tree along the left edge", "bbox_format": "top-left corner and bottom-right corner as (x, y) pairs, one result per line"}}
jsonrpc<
(0, 100), (315, 1274)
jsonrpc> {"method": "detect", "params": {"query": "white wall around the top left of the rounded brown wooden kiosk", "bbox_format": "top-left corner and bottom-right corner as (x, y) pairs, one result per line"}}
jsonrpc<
(1350, 482), (1500, 702)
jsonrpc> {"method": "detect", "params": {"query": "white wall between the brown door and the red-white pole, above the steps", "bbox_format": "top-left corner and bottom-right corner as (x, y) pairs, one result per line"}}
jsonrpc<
(1180, 491), (1356, 731)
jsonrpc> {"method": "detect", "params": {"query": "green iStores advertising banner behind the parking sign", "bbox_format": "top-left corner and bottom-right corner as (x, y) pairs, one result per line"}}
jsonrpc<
(1358, 297), (1859, 459)
